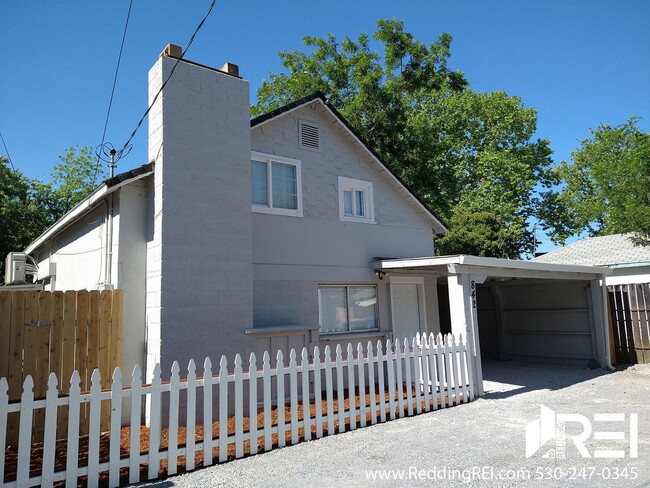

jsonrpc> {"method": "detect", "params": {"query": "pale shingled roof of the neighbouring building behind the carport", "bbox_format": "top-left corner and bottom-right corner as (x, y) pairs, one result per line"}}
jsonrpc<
(533, 234), (650, 267)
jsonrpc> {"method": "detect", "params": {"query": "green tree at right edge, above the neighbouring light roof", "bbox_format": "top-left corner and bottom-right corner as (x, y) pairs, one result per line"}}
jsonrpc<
(549, 117), (650, 245)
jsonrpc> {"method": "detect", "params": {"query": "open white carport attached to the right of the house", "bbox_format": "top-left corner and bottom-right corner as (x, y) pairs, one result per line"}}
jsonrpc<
(373, 255), (611, 395)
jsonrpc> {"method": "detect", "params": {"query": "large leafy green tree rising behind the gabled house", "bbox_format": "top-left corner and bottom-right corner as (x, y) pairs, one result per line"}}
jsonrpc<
(252, 19), (555, 257)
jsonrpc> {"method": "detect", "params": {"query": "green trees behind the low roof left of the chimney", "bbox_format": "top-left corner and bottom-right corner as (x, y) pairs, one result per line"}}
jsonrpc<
(0, 147), (104, 280)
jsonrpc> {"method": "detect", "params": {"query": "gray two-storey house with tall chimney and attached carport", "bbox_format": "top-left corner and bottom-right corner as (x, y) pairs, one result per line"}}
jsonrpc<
(20, 45), (609, 398)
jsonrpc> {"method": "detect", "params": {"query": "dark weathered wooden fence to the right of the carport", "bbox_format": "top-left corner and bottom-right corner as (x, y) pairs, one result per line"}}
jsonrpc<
(608, 283), (650, 364)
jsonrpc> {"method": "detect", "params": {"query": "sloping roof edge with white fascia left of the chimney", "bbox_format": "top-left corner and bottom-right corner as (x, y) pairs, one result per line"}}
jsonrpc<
(25, 162), (154, 254)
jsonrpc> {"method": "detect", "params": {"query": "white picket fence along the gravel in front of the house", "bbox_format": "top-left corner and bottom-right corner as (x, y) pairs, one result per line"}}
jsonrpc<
(0, 335), (475, 487)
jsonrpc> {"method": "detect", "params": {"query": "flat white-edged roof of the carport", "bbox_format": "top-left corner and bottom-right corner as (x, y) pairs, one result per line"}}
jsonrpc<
(373, 254), (612, 280)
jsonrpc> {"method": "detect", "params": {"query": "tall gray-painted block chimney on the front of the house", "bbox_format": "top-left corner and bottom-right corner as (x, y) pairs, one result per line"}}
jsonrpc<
(147, 45), (253, 378)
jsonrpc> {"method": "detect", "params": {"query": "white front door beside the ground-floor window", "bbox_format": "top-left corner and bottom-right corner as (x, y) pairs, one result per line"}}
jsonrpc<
(390, 278), (425, 339)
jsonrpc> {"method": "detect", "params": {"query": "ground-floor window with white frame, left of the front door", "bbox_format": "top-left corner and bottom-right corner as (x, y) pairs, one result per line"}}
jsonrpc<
(318, 285), (379, 334)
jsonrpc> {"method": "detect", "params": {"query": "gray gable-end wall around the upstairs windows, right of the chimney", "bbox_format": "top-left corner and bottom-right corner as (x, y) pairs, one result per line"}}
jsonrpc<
(251, 102), (437, 337)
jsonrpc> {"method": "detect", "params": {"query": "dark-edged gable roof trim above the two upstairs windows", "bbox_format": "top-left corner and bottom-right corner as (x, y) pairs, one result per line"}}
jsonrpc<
(251, 91), (447, 234)
